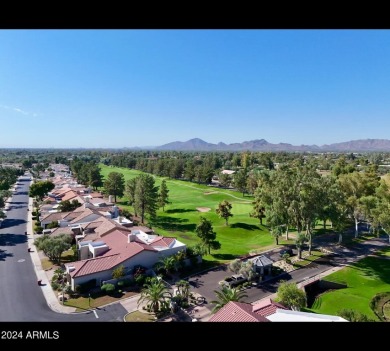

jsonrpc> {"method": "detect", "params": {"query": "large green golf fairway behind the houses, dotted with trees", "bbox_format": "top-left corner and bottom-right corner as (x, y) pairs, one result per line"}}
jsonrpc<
(100, 165), (275, 262)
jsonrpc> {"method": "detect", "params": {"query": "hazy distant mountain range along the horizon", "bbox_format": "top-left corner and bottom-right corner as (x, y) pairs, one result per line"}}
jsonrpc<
(154, 138), (390, 152)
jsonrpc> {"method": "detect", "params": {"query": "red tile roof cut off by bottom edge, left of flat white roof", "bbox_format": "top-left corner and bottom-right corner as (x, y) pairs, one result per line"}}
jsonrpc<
(209, 301), (269, 322)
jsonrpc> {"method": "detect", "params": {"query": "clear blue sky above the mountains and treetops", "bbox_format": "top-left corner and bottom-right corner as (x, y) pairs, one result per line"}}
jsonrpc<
(0, 29), (390, 148)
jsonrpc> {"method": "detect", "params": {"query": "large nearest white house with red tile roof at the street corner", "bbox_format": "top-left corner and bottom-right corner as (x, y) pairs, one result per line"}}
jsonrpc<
(65, 229), (186, 289)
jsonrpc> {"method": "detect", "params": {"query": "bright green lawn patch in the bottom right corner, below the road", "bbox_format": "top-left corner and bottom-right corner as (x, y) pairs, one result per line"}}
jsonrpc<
(311, 257), (390, 320)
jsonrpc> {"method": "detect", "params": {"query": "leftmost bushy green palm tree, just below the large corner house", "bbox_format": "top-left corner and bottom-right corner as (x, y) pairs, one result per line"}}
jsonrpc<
(138, 278), (172, 314)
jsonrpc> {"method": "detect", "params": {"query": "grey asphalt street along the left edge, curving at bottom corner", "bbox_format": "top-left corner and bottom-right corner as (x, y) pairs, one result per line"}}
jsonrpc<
(0, 177), (127, 322)
